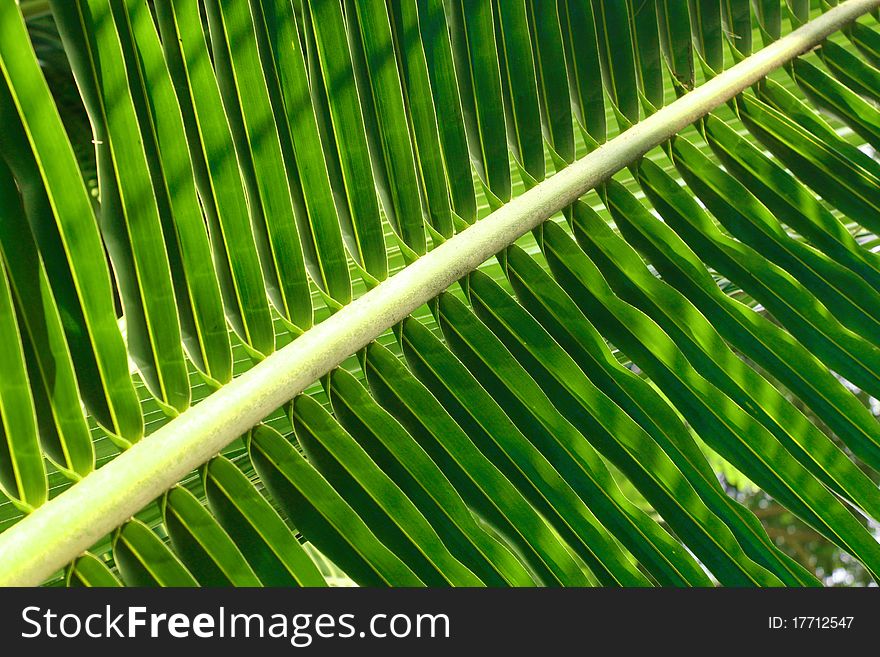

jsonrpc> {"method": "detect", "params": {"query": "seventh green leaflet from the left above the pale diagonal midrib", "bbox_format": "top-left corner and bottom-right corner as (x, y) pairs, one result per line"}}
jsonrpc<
(205, 0), (312, 331)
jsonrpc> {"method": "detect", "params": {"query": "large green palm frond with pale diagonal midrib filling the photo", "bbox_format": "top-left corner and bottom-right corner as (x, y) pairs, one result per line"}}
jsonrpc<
(0, 0), (880, 586)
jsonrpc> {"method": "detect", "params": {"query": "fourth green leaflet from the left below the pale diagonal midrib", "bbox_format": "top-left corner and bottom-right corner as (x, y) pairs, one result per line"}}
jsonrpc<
(202, 456), (326, 586)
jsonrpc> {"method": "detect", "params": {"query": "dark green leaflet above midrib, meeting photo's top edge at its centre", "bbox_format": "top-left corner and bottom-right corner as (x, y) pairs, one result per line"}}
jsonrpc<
(418, 0), (477, 223)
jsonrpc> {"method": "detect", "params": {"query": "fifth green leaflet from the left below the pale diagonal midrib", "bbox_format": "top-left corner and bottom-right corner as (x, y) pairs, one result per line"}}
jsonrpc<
(248, 425), (423, 586)
